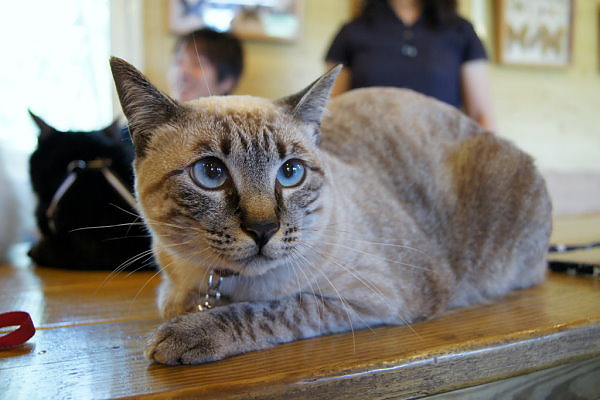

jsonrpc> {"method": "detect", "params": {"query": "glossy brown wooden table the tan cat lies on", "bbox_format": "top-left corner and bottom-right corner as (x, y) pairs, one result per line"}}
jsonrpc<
(0, 215), (600, 400)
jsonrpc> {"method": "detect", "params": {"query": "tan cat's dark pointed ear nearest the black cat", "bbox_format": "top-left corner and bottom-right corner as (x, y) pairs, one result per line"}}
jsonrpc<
(110, 57), (181, 157)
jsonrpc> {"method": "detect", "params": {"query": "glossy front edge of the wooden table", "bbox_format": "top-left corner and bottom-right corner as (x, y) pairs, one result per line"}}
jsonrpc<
(122, 320), (600, 400)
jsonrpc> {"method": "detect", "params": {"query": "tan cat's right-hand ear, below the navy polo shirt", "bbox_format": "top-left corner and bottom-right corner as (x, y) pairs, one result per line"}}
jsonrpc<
(276, 64), (342, 142)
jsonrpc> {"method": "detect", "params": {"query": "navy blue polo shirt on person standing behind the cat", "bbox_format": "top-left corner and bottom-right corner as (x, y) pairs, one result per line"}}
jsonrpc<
(326, 2), (487, 108)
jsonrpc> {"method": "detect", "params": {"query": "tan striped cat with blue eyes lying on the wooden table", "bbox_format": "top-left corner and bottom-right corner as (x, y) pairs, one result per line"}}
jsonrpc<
(111, 58), (551, 365)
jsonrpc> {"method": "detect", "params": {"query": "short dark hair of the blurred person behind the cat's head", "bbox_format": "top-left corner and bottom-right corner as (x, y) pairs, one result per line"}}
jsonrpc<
(175, 28), (244, 82)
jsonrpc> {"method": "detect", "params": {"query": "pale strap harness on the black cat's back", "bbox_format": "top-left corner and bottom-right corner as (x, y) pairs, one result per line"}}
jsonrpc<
(46, 158), (136, 233)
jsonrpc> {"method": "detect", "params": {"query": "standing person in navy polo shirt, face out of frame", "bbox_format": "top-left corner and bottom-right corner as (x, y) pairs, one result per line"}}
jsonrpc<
(325, 0), (495, 131)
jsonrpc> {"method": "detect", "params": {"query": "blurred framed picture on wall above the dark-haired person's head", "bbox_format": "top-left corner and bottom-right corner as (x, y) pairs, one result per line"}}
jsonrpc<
(169, 0), (302, 41)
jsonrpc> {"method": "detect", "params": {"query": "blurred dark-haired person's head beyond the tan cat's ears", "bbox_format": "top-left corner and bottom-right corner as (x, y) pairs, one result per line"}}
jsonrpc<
(169, 28), (244, 101)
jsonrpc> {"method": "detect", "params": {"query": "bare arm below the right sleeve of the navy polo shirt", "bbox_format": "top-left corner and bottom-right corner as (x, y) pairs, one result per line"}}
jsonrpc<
(461, 59), (496, 132)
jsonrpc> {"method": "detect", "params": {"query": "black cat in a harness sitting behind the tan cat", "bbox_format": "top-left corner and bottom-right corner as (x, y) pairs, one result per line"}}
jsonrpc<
(29, 113), (155, 270)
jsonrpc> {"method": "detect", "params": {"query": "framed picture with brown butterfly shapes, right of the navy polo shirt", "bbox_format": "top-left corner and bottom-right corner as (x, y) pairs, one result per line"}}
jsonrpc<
(494, 0), (574, 68)
